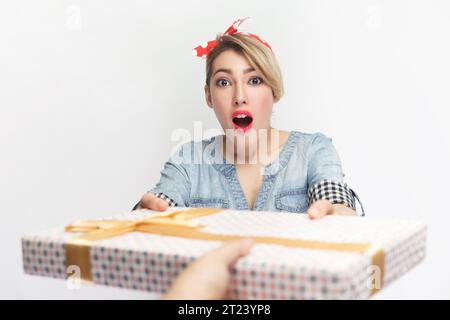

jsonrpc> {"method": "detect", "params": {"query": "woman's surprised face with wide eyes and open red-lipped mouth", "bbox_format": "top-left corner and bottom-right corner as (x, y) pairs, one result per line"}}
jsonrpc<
(205, 50), (274, 135)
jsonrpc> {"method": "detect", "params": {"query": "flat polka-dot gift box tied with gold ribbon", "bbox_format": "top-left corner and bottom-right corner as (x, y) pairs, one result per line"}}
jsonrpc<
(22, 208), (427, 299)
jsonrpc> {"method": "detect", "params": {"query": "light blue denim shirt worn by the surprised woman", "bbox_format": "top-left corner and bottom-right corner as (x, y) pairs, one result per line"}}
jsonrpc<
(149, 131), (345, 213)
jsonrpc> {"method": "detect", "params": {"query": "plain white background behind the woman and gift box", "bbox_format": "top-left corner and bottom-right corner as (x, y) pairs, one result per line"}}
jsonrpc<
(0, 0), (450, 299)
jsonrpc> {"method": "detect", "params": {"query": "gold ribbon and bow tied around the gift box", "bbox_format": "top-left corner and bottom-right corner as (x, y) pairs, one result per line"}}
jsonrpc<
(65, 208), (384, 294)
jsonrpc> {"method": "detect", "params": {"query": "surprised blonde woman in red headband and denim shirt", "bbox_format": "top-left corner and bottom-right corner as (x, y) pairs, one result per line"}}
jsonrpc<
(134, 20), (364, 218)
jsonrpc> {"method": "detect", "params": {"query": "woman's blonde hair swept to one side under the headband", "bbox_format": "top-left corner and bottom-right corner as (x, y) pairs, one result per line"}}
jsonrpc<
(206, 33), (284, 102)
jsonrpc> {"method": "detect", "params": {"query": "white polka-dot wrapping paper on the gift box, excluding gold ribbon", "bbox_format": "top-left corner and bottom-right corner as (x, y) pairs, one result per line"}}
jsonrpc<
(22, 208), (427, 299)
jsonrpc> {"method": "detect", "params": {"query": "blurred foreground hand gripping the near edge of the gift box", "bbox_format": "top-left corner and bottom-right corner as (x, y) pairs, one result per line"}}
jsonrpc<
(162, 239), (253, 300)
